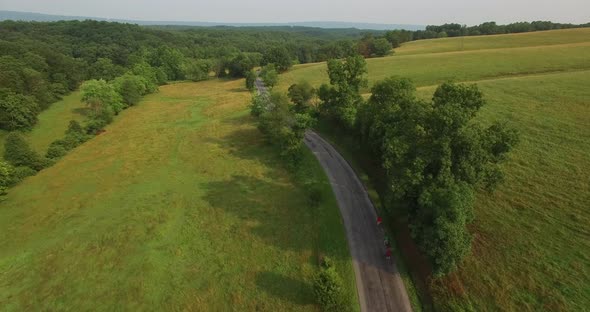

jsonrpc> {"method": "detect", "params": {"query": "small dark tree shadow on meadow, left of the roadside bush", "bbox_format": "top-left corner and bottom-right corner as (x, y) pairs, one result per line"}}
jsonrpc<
(256, 272), (315, 305)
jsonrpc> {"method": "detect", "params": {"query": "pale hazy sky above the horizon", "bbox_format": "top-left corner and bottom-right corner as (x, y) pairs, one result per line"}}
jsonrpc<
(0, 0), (590, 25)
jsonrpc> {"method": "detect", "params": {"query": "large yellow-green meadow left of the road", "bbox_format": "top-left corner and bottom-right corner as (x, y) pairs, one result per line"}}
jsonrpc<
(0, 80), (358, 311)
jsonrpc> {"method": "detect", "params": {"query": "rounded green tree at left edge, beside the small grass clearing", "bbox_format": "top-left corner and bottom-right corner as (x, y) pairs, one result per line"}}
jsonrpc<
(0, 89), (39, 131)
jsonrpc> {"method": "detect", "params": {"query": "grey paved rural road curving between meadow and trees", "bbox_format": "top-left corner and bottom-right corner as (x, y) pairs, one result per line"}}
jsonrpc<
(256, 80), (412, 312)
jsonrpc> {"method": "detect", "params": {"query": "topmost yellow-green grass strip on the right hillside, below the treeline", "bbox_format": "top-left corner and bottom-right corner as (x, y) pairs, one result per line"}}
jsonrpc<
(395, 28), (590, 55)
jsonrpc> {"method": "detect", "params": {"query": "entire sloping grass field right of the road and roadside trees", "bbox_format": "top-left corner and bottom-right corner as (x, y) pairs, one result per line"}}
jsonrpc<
(280, 29), (590, 311)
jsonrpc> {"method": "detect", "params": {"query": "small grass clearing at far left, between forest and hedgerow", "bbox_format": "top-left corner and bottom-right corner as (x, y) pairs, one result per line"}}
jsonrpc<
(0, 91), (85, 155)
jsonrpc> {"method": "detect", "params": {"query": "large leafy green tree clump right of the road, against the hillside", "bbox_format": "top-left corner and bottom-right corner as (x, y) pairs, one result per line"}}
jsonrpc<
(366, 78), (518, 275)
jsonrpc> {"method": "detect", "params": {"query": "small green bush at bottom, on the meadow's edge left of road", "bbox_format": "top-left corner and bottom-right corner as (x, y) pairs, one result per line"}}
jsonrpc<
(314, 258), (350, 312)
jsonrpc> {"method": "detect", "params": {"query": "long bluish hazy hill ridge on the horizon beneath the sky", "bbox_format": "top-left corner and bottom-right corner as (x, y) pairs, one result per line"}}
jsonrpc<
(0, 10), (425, 30)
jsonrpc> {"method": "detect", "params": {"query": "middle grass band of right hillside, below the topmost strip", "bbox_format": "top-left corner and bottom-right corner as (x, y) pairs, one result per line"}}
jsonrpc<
(277, 40), (590, 91)
